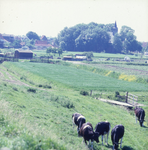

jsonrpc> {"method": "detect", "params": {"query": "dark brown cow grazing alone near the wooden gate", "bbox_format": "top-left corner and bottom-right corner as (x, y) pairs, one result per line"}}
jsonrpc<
(134, 107), (145, 127)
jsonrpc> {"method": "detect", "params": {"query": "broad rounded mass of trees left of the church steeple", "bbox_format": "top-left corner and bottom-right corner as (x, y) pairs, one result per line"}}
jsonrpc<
(58, 22), (109, 52)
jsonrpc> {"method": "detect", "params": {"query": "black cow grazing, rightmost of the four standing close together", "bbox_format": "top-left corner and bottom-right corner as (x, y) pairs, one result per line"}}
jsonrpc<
(111, 124), (124, 150)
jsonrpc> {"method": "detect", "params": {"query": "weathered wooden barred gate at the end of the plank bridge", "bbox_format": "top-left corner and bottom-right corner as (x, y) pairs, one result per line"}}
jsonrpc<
(125, 92), (138, 106)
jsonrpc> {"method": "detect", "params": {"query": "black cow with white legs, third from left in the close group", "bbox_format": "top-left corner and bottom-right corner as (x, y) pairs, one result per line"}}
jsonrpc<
(95, 121), (110, 145)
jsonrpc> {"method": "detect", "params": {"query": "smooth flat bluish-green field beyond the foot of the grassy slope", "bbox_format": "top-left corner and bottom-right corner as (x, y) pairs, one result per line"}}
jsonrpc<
(5, 62), (148, 91)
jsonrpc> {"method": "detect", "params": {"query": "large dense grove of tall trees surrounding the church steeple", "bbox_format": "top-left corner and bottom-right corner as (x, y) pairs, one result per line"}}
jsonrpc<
(58, 22), (142, 53)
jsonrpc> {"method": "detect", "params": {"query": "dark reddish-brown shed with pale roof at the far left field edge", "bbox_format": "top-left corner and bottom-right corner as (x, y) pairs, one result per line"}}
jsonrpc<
(14, 50), (33, 59)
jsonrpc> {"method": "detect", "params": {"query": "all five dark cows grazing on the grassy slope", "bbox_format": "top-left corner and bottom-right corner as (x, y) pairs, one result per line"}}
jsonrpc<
(72, 107), (145, 150)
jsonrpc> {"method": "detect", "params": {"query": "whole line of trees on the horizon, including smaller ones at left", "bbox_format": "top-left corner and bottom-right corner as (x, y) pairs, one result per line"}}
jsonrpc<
(2, 22), (145, 56)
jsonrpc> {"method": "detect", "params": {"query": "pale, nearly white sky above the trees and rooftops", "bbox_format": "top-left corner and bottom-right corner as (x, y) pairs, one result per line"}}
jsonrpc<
(0, 0), (148, 42)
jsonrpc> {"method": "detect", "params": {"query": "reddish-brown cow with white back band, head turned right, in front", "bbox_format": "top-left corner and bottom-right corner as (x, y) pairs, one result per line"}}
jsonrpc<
(80, 122), (99, 149)
